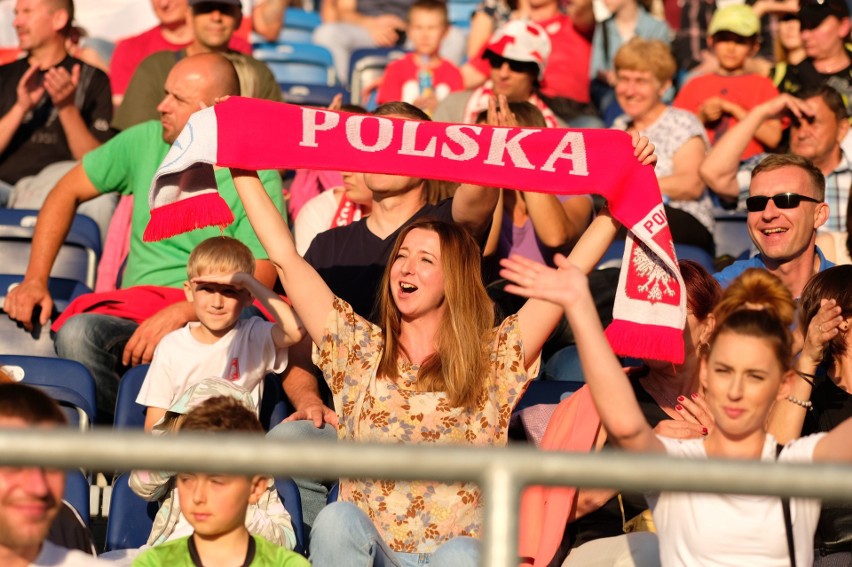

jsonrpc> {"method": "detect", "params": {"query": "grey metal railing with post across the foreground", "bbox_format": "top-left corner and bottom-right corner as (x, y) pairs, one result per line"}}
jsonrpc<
(0, 429), (852, 567)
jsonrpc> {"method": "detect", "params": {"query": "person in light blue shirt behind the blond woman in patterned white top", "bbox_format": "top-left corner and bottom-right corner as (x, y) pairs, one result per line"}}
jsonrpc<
(589, 0), (671, 124)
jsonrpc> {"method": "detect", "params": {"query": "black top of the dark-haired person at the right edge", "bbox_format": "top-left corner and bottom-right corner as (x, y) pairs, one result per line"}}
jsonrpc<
(802, 378), (852, 552)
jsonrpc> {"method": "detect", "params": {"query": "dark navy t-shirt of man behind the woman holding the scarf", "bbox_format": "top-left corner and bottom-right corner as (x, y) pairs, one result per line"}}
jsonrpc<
(305, 199), (453, 321)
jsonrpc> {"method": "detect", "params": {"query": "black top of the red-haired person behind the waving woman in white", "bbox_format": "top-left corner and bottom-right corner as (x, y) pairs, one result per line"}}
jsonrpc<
(548, 374), (671, 566)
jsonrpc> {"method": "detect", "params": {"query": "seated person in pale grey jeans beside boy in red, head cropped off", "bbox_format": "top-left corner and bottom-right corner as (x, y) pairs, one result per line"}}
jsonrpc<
(313, 0), (464, 85)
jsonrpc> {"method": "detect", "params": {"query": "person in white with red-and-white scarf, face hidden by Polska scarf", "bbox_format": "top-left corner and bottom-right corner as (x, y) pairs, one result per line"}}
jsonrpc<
(293, 171), (373, 256)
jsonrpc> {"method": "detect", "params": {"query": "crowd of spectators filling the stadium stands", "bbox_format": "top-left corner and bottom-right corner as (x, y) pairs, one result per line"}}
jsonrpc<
(0, 0), (852, 567)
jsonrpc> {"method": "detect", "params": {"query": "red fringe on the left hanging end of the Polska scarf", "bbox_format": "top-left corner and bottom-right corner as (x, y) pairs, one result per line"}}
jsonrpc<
(142, 192), (234, 242)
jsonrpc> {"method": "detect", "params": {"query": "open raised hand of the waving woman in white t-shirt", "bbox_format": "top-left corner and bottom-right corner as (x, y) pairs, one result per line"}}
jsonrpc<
(500, 254), (589, 307)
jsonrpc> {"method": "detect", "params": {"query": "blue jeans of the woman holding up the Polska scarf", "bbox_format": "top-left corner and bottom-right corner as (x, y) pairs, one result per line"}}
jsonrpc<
(310, 502), (479, 567)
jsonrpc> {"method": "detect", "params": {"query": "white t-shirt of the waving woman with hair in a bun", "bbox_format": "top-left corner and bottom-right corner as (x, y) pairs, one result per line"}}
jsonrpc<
(646, 433), (825, 567)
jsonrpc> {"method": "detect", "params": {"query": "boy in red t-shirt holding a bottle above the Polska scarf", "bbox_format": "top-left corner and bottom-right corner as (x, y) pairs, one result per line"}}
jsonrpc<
(377, 0), (464, 114)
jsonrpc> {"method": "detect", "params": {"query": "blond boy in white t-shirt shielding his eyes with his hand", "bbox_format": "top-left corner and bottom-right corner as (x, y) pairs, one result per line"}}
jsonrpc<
(136, 236), (302, 431)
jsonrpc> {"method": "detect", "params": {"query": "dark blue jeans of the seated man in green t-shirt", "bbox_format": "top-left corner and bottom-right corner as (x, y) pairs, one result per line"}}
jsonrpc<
(54, 313), (139, 423)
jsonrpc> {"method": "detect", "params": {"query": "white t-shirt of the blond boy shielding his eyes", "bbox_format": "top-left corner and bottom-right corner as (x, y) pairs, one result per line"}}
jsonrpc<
(136, 317), (287, 409)
